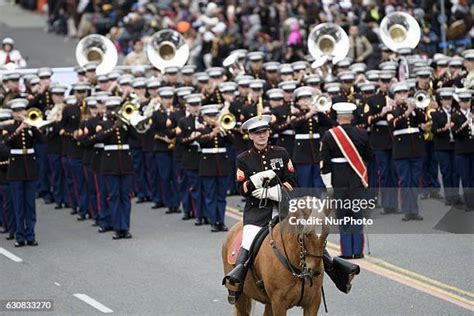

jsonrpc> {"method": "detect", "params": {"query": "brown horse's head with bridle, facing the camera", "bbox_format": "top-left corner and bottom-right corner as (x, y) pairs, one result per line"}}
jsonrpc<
(288, 197), (329, 276)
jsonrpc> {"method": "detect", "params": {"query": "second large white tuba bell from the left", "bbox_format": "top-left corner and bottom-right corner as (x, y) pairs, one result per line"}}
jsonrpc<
(146, 29), (190, 72)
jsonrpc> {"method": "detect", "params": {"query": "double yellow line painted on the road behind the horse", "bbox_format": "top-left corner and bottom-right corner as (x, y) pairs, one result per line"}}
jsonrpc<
(227, 207), (474, 311)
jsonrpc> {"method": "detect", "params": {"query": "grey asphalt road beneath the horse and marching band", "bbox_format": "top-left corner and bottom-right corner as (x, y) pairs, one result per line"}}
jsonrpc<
(0, 2), (474, 315)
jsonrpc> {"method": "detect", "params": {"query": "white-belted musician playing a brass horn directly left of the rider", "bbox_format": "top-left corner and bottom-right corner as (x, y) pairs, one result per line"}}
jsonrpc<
(197, 104), (232, 232)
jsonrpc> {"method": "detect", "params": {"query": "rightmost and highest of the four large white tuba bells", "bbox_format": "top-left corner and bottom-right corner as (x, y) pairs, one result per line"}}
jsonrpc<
(380, 11), (421, 52)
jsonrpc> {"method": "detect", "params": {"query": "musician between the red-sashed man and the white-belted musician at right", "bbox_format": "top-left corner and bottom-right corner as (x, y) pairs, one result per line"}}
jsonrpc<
(367, 71), (399, 215)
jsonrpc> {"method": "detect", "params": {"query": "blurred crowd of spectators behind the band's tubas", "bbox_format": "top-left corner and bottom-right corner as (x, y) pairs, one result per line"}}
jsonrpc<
(15, 0), (474, 69)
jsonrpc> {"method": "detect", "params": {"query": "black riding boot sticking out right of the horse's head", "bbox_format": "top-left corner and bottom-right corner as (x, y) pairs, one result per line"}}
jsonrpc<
(323, 249), (360, 294)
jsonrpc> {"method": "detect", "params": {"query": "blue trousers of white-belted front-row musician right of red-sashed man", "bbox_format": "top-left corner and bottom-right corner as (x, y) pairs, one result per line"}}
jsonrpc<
(395, 158), (423, 214)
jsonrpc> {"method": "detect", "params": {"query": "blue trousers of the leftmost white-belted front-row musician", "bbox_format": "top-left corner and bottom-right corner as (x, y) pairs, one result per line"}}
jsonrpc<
(10, 181), (38, 242)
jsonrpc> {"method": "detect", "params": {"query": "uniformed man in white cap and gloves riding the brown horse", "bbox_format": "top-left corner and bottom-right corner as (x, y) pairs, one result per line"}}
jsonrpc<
(223, 115), (358, 302)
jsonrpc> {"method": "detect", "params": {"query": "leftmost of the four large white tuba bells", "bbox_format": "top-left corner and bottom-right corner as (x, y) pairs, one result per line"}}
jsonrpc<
(76, 34), (118, 75)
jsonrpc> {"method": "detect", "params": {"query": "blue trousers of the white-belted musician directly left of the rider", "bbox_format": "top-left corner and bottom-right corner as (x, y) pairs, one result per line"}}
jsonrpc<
(201, 176), (229, 225)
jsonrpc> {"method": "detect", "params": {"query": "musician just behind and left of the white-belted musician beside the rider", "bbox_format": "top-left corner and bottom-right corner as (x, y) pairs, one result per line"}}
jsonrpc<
(176, 93), (203, 225)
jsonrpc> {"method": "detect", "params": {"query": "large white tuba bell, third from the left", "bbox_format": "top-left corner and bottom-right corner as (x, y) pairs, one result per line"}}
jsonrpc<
(308, 23), (349, 68)
